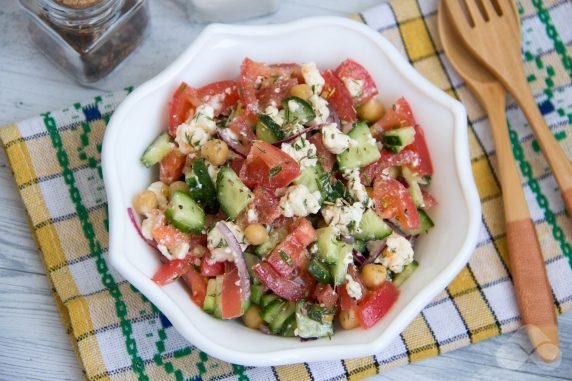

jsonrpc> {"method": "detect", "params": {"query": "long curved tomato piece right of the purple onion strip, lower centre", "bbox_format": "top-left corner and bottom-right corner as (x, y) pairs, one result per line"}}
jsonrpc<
(252, 261), (311, 301)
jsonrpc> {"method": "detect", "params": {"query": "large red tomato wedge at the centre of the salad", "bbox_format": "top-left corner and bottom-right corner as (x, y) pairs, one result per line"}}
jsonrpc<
(240, 140), (301, 189)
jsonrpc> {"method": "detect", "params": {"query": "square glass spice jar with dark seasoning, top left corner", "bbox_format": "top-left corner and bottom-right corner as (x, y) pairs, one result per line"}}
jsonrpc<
(19, 0), (149, 84)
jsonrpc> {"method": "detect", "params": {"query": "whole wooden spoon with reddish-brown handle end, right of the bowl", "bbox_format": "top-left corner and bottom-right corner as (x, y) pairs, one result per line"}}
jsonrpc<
(438, 2), (560, 362)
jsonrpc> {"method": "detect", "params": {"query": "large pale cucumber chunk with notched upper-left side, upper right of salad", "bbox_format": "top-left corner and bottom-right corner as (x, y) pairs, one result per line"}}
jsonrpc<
(337, 122), (381, 170)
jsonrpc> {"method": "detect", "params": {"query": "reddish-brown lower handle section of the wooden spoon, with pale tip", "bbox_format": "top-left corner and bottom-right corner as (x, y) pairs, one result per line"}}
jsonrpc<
(506, 219), (560, 362)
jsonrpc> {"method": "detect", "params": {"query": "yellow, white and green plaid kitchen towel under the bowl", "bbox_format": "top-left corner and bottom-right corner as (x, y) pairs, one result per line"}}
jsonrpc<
(0, 0), (572, 380)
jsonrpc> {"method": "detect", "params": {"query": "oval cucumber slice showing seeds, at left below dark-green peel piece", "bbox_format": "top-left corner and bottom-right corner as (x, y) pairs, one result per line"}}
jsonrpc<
(165, 191), (205, 233)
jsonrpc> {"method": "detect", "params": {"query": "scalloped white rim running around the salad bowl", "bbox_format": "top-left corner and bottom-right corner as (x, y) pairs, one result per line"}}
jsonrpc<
(102, 17), (481, 366)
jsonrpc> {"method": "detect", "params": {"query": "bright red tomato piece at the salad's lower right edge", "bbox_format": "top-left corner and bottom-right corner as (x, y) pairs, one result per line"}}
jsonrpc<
(357, 282), (399, 329)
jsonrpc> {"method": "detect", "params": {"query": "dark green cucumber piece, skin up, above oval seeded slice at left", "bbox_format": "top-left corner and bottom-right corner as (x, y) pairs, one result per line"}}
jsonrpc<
(186, 159), (218, 214)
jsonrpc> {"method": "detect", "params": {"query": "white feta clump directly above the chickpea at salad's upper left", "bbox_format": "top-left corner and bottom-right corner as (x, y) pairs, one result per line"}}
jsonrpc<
(175, 104), (217, 155)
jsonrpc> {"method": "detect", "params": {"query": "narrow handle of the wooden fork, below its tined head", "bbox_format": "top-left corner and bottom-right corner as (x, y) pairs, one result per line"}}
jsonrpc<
(511, 77), (572, 216)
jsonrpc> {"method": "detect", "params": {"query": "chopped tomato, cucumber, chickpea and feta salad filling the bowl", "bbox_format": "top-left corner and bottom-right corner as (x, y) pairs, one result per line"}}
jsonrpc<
(133, 58), (436, 338)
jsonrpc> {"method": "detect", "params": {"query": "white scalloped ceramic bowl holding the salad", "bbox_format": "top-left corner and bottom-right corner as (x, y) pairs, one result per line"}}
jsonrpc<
(102, 17), (481, 366)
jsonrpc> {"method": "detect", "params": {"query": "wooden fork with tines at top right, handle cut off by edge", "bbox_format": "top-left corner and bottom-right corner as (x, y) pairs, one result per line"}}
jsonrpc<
(443, 0), (572, 216)
